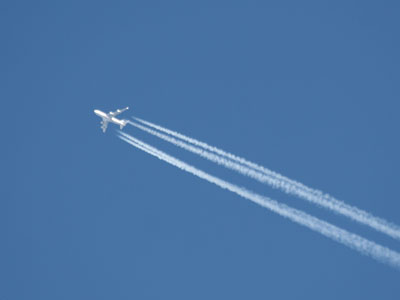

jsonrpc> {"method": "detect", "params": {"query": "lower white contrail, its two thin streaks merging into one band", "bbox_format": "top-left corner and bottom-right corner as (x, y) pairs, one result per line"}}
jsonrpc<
(118, 131), (400, 269)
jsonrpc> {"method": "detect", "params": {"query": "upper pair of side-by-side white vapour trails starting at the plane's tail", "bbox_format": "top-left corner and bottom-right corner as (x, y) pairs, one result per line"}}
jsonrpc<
(130, 118), (400, 240)
